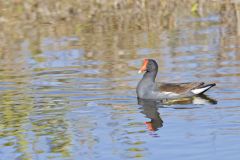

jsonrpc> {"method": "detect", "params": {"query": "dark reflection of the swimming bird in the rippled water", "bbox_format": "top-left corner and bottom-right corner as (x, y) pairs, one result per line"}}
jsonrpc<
(138, 95), (217, 131)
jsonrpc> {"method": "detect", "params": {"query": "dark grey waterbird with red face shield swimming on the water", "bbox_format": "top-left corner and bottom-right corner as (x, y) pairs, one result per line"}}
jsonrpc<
(136, 58), (216, 100)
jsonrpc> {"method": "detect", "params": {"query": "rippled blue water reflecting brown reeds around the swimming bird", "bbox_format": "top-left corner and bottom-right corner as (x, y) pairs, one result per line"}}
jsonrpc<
(0, 1), (240, 160)
